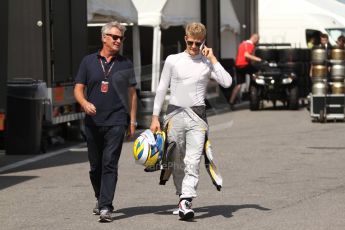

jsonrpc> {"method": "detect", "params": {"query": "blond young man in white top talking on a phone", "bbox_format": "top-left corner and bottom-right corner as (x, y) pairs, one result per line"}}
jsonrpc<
(150, 22), (232, 220)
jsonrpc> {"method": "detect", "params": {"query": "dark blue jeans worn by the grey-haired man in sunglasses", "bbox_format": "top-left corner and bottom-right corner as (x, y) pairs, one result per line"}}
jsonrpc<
(85, 125), (126, 210)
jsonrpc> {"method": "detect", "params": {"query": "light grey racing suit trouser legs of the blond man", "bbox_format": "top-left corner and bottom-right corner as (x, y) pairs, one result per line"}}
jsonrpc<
(168, 111), (207, 198)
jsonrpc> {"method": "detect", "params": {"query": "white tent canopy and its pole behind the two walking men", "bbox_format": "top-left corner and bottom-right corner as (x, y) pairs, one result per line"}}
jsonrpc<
(87, 0), (240, 91)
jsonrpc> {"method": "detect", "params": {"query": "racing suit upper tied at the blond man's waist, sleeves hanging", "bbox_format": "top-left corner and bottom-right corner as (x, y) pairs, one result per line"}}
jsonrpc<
(159, 105), (223, 191)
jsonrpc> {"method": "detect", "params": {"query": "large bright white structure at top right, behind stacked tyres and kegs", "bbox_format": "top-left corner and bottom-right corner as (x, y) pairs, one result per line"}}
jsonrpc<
(259, 0), (345, 48)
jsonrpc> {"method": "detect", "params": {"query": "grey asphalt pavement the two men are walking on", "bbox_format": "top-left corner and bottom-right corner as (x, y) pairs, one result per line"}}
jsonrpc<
(0, 104), (345, 230)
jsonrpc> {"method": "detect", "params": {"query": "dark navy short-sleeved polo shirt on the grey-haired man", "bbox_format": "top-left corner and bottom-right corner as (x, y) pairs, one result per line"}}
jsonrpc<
(75, 52), (136, 126)
